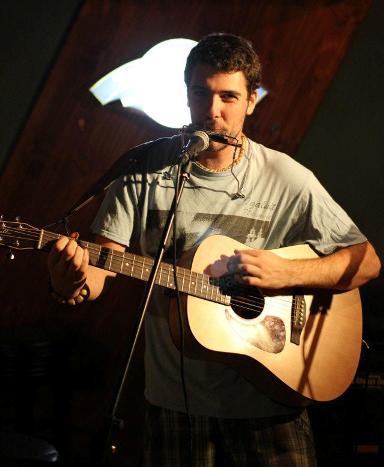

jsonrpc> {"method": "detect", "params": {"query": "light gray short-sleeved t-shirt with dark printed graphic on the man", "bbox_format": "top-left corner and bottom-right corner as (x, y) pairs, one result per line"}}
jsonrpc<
(92, 137), (366, 418)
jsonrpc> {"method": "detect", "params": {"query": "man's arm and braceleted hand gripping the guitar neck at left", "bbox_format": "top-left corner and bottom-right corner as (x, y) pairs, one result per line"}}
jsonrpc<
(48, 236), (125, 300)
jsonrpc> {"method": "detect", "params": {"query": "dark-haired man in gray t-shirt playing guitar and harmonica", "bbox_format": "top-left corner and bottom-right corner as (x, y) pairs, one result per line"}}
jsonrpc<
(49, 34), (380, 466)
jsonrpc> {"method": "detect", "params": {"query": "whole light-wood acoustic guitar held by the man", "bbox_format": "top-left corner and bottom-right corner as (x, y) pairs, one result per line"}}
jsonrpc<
(0, 220), (362, 406)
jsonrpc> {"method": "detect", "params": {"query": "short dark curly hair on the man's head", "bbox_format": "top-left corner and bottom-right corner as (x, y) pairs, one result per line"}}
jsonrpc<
(184, 33), (261, 95)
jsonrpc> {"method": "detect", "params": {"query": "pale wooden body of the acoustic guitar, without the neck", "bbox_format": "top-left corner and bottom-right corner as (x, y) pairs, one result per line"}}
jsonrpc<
(170, 235), (362, 406)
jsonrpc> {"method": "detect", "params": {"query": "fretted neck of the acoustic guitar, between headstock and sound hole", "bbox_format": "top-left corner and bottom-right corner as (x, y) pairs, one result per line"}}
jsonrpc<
(37, 229), (230, 304)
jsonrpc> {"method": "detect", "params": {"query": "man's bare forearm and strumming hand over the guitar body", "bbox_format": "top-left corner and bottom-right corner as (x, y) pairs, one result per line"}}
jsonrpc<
(232, 241), (381, 290)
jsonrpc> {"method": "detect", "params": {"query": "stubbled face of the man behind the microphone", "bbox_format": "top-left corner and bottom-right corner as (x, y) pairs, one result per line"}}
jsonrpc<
(188, 64), (256, 149)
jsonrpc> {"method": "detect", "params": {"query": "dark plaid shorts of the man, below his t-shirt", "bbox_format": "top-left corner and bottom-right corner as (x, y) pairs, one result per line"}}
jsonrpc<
(143, 405), (316, 467)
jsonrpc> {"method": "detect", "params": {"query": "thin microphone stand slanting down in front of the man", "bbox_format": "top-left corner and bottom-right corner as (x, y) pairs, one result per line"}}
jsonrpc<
(96, 148), (199, 465)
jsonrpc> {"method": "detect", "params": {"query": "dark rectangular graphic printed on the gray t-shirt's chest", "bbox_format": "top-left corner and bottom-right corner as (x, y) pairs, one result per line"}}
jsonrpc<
(146, 210), (270, 254)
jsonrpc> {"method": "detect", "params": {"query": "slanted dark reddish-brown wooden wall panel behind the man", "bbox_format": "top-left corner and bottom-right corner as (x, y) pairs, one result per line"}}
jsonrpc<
(0, 0), (376, 465)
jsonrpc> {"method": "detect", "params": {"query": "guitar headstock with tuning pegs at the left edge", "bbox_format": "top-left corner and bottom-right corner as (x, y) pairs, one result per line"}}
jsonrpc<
(0, 217), (41, 250)
